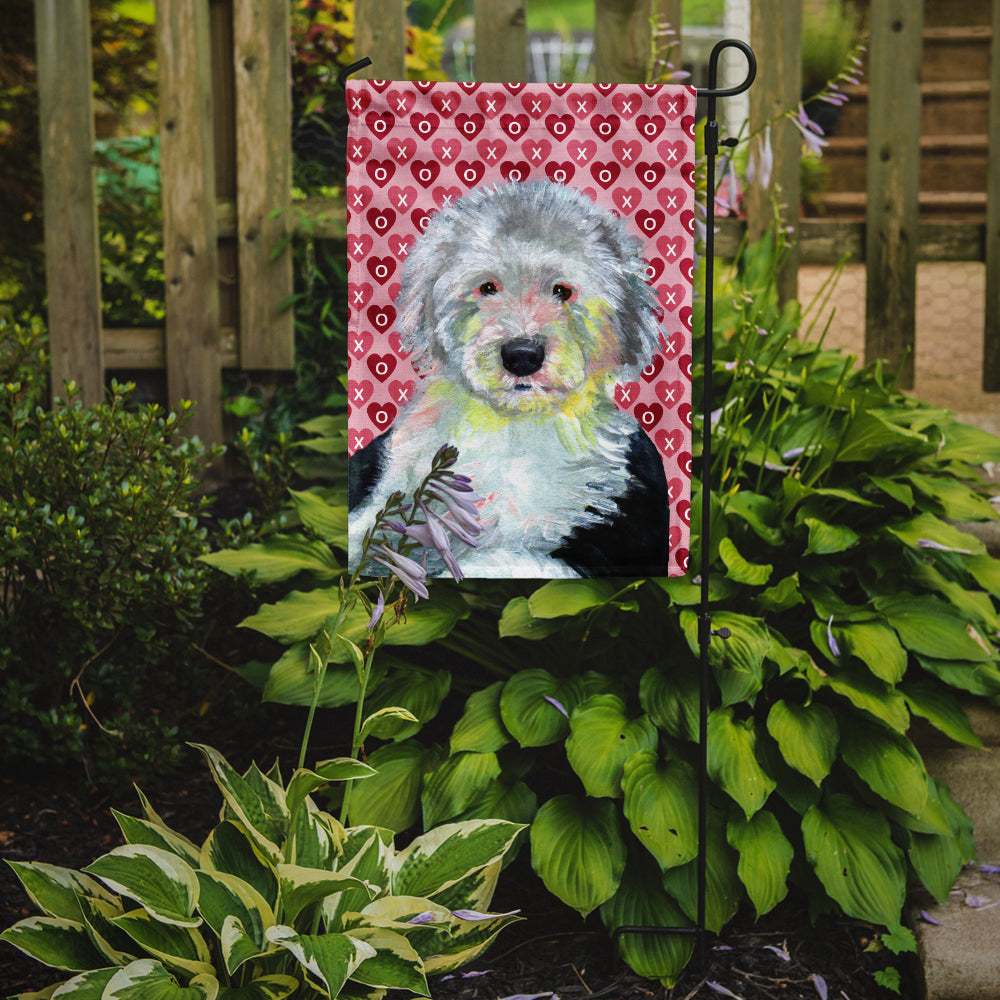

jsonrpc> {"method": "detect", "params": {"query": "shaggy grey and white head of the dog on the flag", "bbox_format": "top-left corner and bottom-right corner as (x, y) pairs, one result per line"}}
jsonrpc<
(397, 182), (659, 412)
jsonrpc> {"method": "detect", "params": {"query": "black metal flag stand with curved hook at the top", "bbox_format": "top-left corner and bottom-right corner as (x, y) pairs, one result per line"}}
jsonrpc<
(612, 38), (757, 971)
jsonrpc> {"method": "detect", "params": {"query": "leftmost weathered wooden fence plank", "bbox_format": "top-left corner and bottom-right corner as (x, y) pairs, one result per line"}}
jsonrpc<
(35, 0), (104, 404)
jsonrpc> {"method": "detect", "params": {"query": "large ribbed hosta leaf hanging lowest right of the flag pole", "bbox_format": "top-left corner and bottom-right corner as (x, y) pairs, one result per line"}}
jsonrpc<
(802, 794), (906, 926)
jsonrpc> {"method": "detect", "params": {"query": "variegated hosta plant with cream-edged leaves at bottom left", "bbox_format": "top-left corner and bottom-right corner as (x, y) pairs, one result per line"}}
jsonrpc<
(0, 746), (521, 1000)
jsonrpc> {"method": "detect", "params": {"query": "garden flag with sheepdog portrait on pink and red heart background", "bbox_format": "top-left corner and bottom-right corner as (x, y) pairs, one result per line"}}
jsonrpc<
(347, 80), (695, 577)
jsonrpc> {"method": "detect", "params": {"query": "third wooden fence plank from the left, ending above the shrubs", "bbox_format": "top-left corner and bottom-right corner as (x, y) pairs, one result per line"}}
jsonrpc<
(233, 0), (295, 369)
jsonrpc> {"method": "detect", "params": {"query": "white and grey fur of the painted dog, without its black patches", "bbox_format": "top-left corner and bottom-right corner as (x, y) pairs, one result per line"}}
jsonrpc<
(350, 176), (659, 577)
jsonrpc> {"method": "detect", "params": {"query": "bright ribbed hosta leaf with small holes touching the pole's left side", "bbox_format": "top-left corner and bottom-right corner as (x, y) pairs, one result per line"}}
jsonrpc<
(622, 750), (698, 869)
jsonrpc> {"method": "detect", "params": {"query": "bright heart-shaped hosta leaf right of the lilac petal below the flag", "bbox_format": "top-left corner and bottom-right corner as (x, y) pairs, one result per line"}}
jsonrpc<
(566, 694), (659, 799)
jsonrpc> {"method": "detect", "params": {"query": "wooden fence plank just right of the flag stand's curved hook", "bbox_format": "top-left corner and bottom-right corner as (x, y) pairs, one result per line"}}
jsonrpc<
(747, 0), (802, 302)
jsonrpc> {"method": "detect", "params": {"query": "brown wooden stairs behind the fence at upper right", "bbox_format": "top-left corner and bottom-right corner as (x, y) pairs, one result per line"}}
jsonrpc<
(817, 0), (991, 222)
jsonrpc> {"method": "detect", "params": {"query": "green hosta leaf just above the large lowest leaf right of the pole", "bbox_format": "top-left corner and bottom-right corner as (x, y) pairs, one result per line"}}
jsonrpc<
(840, 718), (927, 815)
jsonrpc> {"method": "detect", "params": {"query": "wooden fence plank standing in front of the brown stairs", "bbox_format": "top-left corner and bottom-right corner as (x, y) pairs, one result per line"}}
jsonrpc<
(865, 0), (923, 389)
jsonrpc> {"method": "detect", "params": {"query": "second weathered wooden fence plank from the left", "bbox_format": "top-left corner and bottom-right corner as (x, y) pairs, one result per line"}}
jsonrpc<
(156, 0), (222, 443)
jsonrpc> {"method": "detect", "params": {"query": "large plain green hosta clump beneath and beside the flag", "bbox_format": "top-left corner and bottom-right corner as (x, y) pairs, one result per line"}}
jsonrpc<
(201, 229), (1000, 983)
